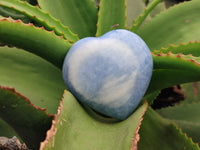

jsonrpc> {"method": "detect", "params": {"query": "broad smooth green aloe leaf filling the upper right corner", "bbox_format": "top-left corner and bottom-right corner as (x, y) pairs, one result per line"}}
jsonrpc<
(138, 0), (200, 50)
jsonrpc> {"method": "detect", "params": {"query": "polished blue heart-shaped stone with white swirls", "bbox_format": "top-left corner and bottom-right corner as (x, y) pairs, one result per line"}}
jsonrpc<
(63, 29), (153, 120)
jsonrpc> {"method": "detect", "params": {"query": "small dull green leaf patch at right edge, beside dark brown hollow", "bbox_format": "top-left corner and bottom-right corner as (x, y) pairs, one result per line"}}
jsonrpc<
(181, 82), (200, 105)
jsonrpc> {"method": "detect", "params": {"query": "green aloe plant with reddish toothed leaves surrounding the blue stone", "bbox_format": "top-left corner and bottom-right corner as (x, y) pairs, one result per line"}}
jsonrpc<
(0, 0), (200, 150)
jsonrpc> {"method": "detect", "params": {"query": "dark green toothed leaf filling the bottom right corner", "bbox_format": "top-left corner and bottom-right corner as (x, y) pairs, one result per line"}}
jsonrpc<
(138, 107), (200, 150)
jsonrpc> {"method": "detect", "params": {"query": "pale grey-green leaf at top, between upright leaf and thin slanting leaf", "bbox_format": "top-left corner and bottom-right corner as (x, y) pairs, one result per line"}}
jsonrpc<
(126, 0), (145, 27)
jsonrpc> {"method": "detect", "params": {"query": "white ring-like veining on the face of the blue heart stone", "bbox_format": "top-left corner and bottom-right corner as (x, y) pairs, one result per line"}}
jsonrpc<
(68, 38), (138, 107)
